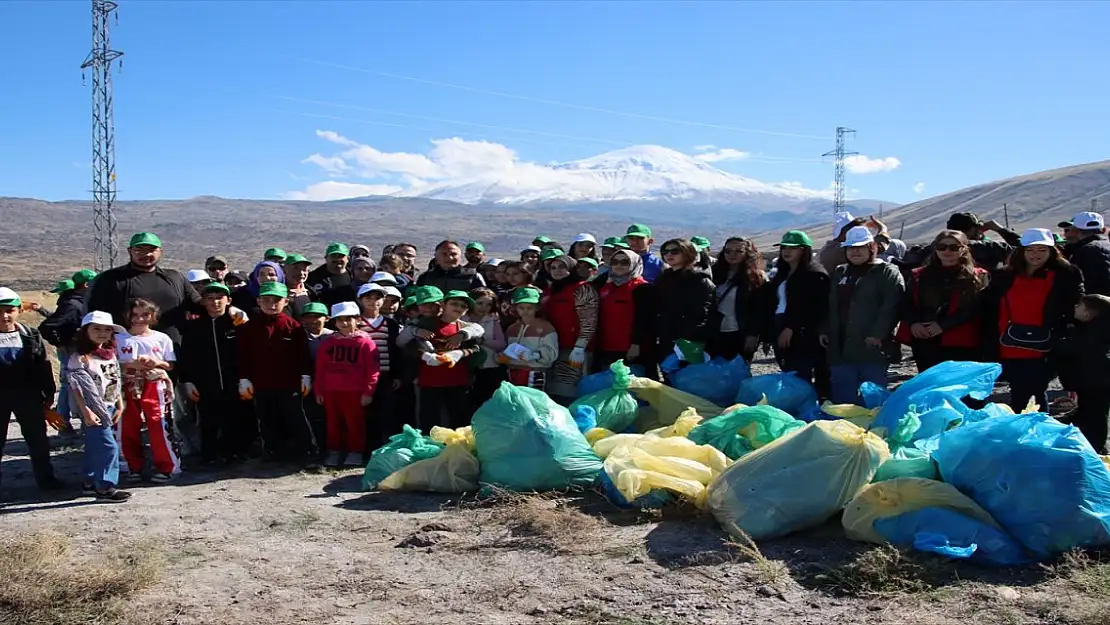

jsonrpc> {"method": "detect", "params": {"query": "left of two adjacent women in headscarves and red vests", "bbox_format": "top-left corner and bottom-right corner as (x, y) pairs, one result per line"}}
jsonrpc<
(543, 254), (599, 405)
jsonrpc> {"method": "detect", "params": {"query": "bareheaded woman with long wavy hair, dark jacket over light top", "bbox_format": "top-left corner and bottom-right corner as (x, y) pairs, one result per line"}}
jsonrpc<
(706, 236), (767, 362)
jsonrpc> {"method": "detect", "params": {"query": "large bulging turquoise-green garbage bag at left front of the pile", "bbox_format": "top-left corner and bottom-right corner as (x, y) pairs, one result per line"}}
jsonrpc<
(471, 382), (602, 492)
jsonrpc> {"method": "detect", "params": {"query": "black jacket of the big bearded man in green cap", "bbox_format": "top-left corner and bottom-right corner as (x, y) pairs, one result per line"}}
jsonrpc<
(85, 264), (205, 345)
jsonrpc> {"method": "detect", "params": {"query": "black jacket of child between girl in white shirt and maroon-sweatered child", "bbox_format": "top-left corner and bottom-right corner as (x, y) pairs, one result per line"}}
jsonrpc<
(178, 313), (240, 395)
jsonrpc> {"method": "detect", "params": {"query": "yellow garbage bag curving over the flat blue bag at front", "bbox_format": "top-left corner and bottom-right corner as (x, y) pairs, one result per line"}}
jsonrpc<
(841, 477), (1001, 545)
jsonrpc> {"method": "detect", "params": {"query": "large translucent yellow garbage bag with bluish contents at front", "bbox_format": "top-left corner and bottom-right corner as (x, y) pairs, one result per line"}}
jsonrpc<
(707, 421), (890, 540)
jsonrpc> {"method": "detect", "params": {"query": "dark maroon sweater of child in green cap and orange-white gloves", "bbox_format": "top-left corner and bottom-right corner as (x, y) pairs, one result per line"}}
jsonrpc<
(238, 313), (312, 391)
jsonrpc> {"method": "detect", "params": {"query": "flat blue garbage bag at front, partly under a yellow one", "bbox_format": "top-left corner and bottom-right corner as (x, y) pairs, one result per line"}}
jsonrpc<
(874, 507), (1030, 566)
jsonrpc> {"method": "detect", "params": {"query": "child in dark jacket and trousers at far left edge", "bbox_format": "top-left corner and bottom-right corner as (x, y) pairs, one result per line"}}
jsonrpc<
(0, 286), (64, 499)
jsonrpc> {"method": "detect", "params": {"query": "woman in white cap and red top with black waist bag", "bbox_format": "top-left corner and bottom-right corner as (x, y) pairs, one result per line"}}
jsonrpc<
(987, 228), (1083, 413)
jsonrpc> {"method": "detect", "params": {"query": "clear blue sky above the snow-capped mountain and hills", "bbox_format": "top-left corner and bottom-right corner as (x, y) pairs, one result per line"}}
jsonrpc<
(0, 0), (1110, 202)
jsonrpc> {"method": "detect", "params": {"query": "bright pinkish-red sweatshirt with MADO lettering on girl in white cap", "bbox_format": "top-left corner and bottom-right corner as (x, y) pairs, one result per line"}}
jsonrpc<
(313, 332), (382, 395)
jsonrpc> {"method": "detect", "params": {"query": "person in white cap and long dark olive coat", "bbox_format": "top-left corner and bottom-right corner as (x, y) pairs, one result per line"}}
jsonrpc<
(819, 225), (905, 404)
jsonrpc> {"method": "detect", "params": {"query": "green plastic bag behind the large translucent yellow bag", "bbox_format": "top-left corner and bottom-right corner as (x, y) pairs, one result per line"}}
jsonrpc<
(687, 405), (806, 460)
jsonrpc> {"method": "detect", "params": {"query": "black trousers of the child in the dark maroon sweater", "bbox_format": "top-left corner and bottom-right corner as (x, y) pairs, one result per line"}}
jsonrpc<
(254, 390), (319, 460)
